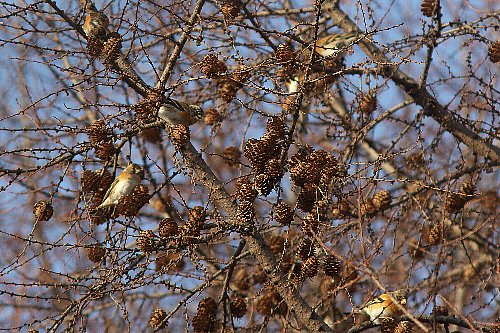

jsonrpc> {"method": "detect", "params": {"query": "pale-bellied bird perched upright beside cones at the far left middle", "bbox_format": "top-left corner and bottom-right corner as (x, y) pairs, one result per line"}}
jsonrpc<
(97, 163), (144, 208)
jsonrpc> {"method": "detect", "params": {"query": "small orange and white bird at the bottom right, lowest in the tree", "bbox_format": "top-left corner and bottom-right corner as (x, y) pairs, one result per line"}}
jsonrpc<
(361, 289), (408, 324)
